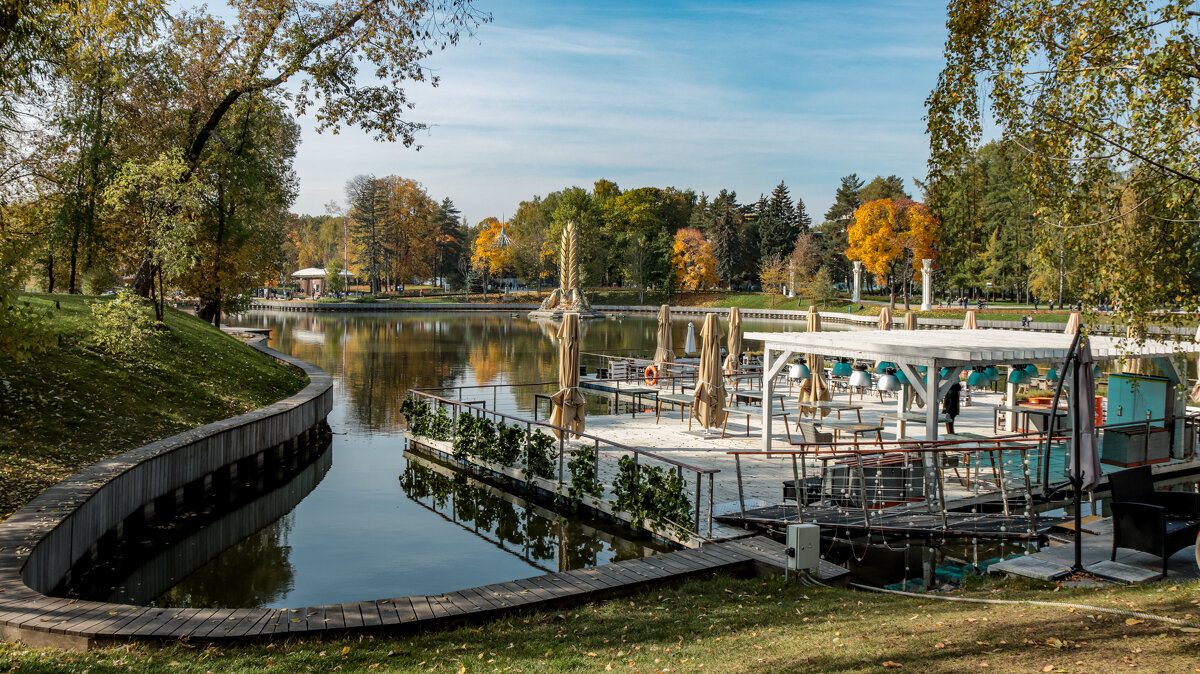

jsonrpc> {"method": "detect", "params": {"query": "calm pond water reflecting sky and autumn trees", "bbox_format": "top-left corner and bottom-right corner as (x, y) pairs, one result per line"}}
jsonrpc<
(145, 312), (830, 607)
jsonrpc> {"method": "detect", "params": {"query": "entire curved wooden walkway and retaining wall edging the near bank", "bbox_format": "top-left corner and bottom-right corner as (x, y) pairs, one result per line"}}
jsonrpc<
(0, 339), (796, 650)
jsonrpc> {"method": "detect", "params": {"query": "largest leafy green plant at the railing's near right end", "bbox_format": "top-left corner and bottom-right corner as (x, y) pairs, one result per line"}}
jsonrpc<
(612, 457), (692, 541)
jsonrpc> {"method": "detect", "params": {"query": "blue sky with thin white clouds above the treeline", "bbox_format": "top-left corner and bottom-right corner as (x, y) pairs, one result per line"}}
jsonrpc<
(293, 0), (946, 223)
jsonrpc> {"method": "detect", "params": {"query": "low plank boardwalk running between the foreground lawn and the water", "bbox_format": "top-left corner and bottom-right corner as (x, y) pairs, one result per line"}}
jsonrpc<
(0, 536), (847, 649)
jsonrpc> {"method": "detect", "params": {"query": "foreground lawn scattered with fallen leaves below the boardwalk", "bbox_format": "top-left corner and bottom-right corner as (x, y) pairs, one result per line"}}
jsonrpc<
(0, 568), (1200, 673)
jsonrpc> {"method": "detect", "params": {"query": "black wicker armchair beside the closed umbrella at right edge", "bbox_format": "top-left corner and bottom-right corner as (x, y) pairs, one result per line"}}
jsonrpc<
(1109, 465), (1200, 577)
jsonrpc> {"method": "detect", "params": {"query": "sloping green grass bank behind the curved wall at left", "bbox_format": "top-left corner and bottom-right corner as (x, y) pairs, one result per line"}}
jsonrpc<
(0, 295), (304, 519)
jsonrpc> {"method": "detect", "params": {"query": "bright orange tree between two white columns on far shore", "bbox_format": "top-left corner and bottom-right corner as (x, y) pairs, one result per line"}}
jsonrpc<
(846, 199), (941, 308)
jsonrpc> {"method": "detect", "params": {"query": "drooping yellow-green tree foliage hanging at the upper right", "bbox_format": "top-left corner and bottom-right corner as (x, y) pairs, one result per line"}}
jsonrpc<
(926, 0), (1200, 324)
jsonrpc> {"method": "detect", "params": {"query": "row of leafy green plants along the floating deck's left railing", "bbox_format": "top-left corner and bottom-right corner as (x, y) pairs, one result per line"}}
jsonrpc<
(401, 390), (719, 541)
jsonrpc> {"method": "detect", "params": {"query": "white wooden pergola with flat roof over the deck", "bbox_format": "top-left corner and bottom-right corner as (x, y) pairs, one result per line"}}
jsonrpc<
(745, 330), (1200, 451)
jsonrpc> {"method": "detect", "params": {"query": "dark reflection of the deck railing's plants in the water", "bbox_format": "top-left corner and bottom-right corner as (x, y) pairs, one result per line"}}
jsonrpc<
(400, 455), (668, 572)
